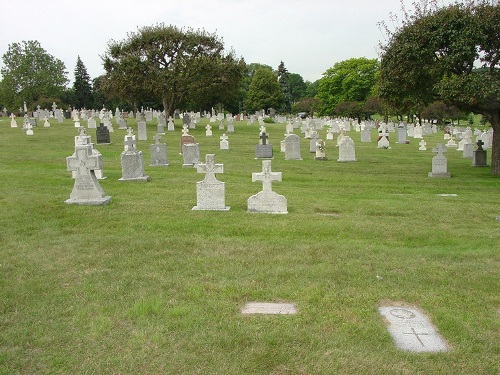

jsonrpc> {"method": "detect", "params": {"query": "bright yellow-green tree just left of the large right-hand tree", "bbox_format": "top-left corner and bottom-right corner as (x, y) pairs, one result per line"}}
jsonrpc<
(317, 57), (379, 115)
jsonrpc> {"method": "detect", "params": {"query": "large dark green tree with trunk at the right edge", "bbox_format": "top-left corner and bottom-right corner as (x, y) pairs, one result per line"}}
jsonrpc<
(379, 0), (500, 175)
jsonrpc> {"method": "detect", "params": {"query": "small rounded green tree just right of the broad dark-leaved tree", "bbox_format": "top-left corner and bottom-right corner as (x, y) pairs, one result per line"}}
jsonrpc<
(244, 68), (284, 112)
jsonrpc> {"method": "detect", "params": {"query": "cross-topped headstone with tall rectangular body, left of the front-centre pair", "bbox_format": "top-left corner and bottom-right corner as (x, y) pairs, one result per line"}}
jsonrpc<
(193, 154), (230, 211)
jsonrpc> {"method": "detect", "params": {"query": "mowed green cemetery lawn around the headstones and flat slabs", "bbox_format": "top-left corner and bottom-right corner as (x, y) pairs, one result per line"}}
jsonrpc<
(0, 118), (500, 374)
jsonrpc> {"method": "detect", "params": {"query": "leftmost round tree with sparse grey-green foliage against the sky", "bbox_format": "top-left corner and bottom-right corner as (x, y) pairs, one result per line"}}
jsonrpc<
(0, 40), (68, 109)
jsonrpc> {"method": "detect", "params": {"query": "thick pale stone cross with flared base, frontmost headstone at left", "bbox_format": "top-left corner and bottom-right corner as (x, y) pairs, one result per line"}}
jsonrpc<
(65, 144), (111, 205)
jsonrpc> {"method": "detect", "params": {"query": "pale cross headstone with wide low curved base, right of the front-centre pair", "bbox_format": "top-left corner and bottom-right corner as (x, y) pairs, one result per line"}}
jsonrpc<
(247, 160), (288, 214)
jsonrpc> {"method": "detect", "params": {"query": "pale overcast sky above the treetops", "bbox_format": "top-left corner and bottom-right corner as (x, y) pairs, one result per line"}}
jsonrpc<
(0, 0), (454, 82)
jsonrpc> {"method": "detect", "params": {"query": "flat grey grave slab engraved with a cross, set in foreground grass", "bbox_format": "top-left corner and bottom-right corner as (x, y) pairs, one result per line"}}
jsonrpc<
(379, 306), (448, 352)
